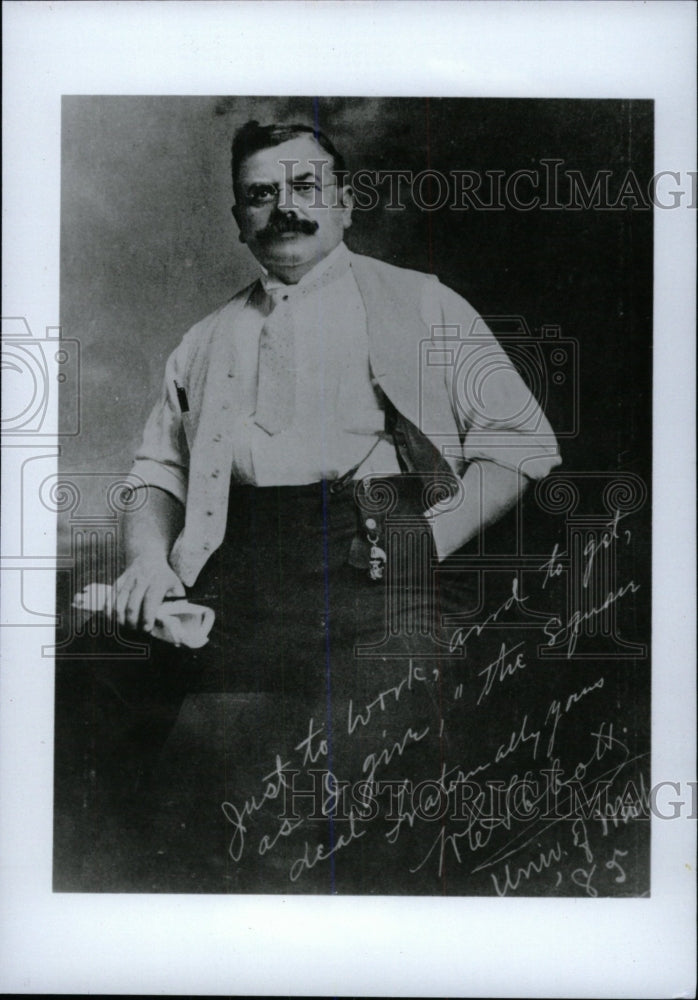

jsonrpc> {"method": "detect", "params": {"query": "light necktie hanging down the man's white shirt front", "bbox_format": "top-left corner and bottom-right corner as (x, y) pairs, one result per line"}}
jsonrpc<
(254, 288), (296, 434)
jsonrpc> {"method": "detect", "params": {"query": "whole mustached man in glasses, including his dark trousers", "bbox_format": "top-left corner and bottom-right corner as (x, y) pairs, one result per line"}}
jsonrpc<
(83, 122), (559, 886)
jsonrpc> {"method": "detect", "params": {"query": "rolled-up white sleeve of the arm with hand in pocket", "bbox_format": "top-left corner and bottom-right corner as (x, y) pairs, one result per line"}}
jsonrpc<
(418, 281), (561, 479)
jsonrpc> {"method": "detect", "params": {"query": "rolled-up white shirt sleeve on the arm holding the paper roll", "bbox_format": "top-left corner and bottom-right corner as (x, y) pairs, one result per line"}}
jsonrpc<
(131, 335), (190, 504)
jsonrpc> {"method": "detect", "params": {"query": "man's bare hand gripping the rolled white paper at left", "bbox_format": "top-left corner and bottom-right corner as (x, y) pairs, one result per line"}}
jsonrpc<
(114, 556), (186, 632)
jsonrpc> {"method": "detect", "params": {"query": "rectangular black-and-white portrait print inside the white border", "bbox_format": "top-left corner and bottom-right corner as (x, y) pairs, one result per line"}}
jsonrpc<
(53, 96), (652, 898)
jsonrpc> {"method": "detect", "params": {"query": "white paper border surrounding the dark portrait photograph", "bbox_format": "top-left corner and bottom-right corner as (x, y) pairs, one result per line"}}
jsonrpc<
(0, 0), (696, 997)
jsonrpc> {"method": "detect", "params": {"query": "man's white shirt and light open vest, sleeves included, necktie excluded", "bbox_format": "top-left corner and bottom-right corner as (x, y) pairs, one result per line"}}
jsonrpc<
(133, 245), (560, 585)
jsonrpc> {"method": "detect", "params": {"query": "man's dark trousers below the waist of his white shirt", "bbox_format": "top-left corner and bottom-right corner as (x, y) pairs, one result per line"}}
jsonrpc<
(190, 477), (433, 700)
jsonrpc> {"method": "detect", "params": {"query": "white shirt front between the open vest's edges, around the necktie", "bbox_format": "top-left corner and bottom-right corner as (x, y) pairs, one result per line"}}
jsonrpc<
(223, 243), (400, 486)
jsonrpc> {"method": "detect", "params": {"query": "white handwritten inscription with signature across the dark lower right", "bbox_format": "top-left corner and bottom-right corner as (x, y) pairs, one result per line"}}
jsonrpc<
(222, 504), (648, 898)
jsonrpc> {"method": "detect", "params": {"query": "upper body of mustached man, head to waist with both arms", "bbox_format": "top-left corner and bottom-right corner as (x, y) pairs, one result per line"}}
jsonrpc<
(116, 122), (559, 631)
